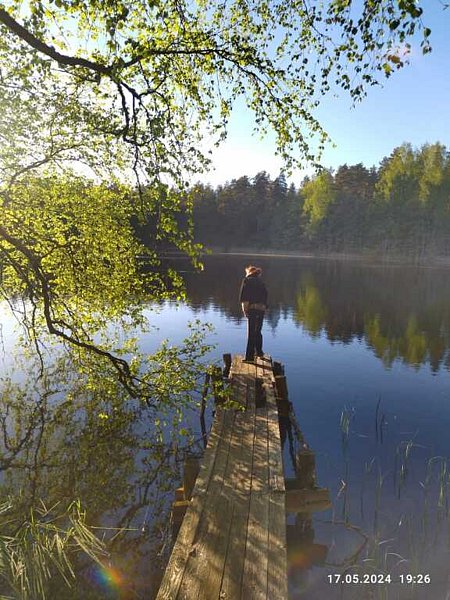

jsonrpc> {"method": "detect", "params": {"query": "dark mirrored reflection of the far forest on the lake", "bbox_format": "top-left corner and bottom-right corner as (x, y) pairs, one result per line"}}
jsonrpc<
(181, 256), (450, 372)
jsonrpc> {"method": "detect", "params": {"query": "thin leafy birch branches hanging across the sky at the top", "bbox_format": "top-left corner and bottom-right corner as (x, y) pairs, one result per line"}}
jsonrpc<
(0, 0), (430, 178)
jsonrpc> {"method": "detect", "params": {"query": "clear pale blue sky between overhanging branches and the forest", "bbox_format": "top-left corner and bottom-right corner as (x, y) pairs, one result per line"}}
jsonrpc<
(201, 0), (450, 185)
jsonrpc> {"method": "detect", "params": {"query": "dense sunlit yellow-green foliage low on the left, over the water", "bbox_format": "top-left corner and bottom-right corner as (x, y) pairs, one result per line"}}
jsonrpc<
(0, 166), (211, 405)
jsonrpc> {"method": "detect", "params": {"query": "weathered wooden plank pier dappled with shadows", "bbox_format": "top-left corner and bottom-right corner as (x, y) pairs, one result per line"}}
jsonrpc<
(157, 356), (287, 600)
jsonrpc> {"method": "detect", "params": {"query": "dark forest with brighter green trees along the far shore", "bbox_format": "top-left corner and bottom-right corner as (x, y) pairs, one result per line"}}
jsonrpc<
(187, 143), (450, 259)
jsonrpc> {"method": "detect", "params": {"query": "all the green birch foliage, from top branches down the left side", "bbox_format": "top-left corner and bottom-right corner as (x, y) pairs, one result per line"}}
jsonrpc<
(0, 0), (431, 394)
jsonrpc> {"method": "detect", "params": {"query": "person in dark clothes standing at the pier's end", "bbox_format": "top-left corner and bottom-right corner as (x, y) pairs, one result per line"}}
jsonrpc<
(239, 265), (267, 362)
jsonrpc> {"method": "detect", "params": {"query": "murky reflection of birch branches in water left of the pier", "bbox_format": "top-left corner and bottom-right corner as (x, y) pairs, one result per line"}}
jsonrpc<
(0, 357), (192, 600)
